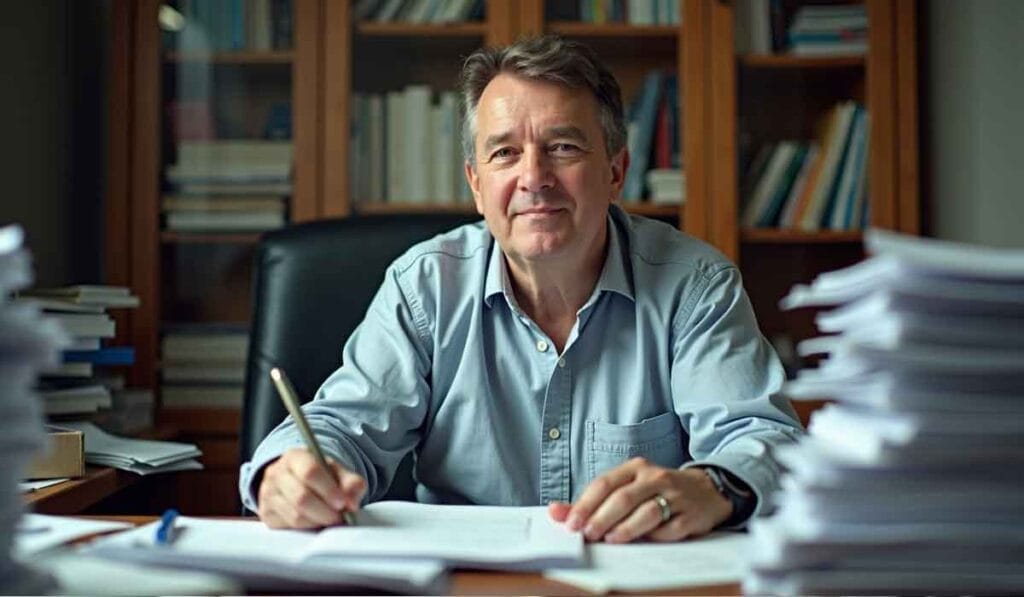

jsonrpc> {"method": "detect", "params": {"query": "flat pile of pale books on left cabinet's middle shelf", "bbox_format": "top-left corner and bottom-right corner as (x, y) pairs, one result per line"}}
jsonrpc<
(161, 139), (292, 231)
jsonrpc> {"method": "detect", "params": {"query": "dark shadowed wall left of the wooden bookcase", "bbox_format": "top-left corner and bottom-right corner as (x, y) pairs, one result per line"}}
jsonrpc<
(0, 0), (110, 285)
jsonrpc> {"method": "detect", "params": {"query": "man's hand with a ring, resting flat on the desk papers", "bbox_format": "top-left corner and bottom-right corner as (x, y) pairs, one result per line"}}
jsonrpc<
(548, 458), (732, 543)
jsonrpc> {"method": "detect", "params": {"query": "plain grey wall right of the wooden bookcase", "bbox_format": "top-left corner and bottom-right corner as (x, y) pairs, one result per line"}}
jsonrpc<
(921, 0), (1024, 247)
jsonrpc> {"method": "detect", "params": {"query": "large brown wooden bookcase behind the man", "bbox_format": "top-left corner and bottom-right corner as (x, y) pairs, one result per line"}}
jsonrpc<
(105, 0), (920, 514)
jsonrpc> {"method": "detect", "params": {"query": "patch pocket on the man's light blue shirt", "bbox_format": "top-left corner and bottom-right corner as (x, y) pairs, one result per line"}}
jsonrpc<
(587, 413), (685, 480)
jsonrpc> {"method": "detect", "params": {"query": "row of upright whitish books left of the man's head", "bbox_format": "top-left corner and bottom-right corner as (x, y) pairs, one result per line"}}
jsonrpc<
(350, 85), (472, 205)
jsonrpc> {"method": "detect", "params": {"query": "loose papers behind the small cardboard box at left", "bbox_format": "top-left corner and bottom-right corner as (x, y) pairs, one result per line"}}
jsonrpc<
(62, 421), (203, 475)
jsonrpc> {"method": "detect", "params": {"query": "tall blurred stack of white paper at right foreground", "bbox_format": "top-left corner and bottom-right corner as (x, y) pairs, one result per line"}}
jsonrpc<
(744, 230), (1024, 594)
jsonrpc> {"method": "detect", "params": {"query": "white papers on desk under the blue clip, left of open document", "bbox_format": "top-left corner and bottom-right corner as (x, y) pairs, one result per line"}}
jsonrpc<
(87, 516), (444, 593)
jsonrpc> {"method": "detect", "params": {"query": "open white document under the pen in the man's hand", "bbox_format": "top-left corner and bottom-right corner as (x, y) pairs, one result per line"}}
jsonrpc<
(302, 502), (584, 570)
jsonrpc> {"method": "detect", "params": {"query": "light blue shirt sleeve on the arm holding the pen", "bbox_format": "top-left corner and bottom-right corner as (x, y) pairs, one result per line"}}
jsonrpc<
(239, 266), (431, 511)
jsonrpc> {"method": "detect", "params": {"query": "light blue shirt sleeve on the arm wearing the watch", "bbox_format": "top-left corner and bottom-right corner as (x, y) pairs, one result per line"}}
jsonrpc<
(672, 265), (803, 517)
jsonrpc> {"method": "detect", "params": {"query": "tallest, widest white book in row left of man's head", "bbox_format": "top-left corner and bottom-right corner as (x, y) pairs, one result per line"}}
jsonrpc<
(401, 85), (434, 203)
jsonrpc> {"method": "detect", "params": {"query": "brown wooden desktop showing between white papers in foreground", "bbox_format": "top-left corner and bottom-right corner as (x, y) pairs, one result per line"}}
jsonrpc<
(77, 516), (742, 596)
